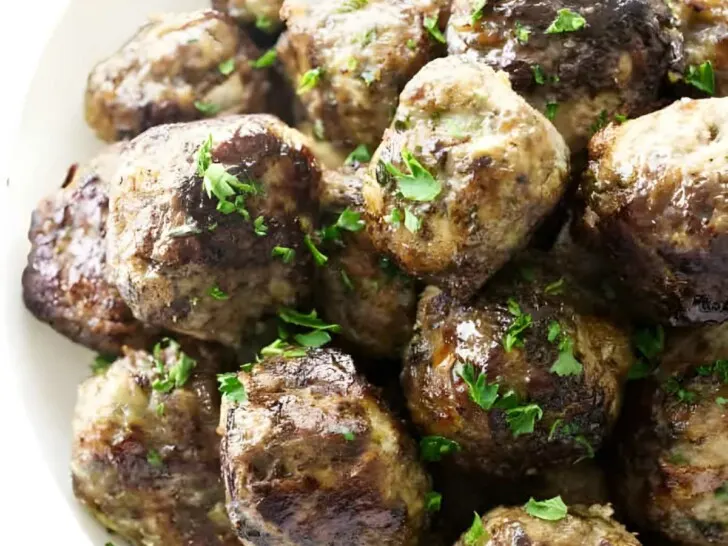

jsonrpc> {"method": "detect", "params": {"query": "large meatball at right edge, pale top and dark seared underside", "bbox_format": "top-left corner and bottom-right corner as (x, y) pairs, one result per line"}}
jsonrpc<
(582, 99), (728, 325)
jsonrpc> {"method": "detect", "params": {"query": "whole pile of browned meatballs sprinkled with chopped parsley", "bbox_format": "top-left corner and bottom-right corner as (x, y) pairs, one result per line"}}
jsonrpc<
(23, 0), (728, 546)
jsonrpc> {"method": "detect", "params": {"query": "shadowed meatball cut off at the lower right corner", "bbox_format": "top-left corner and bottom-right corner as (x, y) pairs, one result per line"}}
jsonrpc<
(616, 352), (728, 546)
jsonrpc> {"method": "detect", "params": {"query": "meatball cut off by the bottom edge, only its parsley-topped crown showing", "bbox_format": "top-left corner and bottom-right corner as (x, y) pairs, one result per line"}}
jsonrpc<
(455, 504), (640, 546)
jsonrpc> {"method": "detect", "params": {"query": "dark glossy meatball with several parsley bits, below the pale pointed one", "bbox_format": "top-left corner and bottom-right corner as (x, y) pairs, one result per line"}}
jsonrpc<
(402, 258), (632, 477)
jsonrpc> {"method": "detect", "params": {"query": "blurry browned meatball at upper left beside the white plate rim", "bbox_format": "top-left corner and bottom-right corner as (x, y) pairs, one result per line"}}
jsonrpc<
(86, 10), (268, 141)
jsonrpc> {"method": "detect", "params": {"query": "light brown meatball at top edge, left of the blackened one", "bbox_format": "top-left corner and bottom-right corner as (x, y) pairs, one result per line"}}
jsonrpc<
(278, 0), (448, 149)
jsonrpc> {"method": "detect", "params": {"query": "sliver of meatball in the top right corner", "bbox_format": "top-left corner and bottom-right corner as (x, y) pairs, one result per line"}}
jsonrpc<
(667, 0), (728, 97)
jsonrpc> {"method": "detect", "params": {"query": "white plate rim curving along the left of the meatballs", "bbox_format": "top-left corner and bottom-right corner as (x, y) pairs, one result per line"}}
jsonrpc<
(0, 0), (209, 546)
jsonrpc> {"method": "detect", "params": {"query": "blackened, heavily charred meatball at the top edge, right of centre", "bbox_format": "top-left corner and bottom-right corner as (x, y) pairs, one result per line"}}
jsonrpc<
(447, 0), (679, 152)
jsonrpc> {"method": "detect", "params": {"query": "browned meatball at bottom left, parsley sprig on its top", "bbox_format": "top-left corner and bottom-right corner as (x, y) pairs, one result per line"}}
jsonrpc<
(71, 340), (238, 546)
